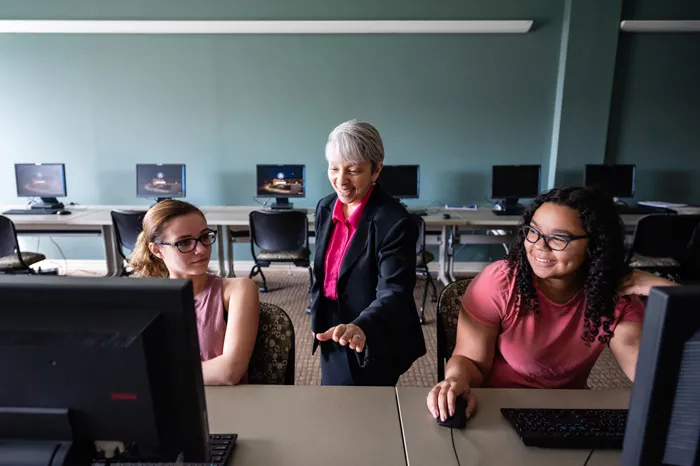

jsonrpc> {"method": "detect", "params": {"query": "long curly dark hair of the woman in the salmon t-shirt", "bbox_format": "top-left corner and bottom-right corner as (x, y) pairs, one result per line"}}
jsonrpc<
(506, 187), (628, 346)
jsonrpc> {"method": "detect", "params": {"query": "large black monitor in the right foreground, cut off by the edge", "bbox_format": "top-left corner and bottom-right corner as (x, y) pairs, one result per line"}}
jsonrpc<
(621, 285), (700, 466)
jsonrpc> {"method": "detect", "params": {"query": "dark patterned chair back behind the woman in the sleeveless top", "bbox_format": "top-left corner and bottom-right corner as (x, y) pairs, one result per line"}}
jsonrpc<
(248, 303), (295, 385)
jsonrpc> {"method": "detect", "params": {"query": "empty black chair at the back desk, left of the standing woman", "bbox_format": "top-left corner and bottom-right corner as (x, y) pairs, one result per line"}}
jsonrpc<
(249, 210), (314, 293)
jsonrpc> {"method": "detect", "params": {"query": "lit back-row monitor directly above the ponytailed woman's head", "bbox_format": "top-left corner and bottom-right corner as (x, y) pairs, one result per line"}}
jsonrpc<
(136, 163), (186, 202)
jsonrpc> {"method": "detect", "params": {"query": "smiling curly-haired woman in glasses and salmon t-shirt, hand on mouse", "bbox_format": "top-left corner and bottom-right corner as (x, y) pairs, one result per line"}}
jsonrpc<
(427, 188), (670, 420)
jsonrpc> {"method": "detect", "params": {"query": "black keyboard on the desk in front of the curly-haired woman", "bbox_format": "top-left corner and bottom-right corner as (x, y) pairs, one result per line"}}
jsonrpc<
(501, 408), (627, 449)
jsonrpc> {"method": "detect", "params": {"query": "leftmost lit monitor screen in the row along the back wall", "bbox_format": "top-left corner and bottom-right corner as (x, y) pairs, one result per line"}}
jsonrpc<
(15, 163), (66, 197)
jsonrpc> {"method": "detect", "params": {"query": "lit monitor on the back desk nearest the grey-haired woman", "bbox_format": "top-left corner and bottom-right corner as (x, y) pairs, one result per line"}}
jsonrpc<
(256, 165), (306, 209)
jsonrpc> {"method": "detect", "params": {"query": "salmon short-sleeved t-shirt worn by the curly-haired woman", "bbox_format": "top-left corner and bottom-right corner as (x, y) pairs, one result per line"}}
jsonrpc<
(462, 260), (644, 388)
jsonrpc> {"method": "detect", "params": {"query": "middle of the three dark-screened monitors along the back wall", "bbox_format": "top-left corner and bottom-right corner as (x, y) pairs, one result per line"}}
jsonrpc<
(491, 165), (542, 215)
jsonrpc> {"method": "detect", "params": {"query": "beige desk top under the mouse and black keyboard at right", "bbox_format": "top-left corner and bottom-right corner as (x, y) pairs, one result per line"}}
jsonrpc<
(396, 388), (629, 466)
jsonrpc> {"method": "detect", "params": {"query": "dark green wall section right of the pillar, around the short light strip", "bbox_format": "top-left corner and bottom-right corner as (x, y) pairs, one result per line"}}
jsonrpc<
(606, 0), (700, 203)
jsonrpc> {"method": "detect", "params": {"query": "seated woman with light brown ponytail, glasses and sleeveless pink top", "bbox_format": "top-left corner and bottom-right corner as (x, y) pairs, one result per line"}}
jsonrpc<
(130, 200), (260, 385)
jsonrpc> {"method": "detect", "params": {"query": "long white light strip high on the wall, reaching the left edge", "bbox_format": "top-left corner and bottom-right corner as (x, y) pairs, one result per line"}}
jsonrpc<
(0, 20), (533, 34)
